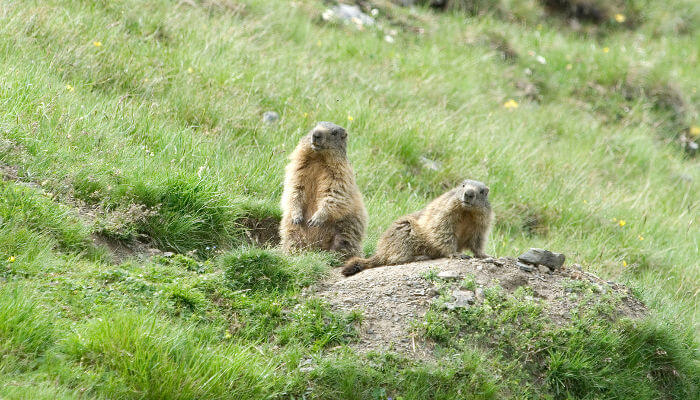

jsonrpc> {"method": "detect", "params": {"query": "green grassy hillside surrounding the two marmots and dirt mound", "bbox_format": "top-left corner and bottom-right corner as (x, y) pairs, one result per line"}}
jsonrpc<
(0, 0), (700, 399)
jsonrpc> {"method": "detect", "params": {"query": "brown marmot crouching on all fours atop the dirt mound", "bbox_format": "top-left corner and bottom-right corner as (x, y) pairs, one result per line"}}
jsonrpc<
(343, 180), (493, 276)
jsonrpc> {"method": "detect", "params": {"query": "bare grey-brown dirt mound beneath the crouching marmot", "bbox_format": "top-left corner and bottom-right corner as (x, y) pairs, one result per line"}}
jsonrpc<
(316, 258), (646, 359)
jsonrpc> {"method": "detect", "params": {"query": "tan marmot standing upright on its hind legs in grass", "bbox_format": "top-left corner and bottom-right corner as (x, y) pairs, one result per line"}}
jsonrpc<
(280, 122), (367, 260)
